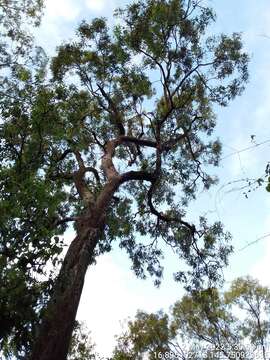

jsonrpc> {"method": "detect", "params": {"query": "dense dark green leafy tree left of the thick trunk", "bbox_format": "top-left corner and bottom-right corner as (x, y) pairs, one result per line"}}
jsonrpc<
(0, 66), (61, 359)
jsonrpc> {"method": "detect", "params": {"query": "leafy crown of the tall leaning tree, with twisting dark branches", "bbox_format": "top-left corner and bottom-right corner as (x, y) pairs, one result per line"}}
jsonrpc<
(48, 1), (248, 285)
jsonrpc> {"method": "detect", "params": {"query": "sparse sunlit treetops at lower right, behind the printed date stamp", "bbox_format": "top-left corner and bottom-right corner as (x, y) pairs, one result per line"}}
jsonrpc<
(112, 277), (270, 360)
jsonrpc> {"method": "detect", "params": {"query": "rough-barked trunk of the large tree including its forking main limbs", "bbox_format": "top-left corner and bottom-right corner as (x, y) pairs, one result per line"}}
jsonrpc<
(29, 138), (154, 360)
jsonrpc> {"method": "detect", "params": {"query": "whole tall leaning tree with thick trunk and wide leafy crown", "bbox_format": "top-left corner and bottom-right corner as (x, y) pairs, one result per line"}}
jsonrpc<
(1, 0), (248, 360)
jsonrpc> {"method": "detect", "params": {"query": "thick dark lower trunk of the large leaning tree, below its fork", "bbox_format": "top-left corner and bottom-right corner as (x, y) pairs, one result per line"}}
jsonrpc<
(30, 222), (101, 360)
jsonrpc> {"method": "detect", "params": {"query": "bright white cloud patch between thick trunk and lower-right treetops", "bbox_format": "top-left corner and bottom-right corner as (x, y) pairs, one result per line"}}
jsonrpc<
(77, 254), (180, 356)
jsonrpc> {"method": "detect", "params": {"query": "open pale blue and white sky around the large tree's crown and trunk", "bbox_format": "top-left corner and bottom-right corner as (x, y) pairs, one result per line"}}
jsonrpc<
(36, 0), (270, 355)
